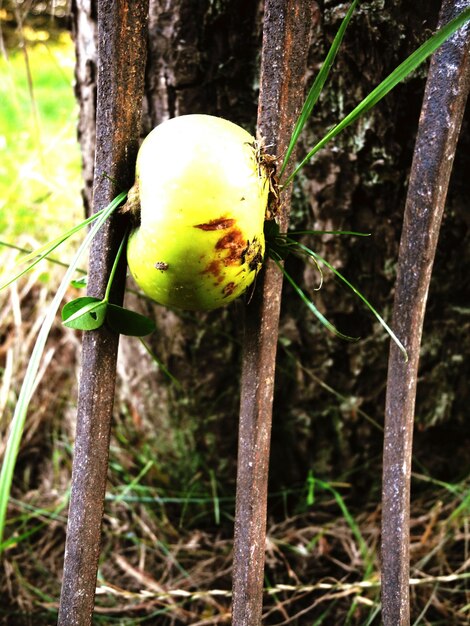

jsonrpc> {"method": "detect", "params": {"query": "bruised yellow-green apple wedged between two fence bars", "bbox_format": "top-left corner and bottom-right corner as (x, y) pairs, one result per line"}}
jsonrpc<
(127, 115), (269, 310)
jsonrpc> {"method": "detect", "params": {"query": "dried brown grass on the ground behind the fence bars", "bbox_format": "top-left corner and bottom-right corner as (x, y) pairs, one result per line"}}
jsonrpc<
(0, 251), (470, 626)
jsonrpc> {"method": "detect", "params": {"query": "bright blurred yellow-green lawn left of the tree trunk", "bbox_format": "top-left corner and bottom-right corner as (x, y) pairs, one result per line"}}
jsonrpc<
(0, 27), (83, 245)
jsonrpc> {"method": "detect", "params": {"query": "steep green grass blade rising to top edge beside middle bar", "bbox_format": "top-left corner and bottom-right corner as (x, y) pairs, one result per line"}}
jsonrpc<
(279, 0), (358, 178)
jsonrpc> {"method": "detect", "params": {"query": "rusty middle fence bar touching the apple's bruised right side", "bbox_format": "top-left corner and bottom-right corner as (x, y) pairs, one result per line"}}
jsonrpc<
(232, 0), (316, 626)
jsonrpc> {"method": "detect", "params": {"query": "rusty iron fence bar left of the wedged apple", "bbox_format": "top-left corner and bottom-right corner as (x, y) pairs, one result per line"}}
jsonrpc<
(58, 0), (148, 626)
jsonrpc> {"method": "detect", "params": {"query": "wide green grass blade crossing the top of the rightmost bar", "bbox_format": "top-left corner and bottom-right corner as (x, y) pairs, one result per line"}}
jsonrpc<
(283, 7), (470, 187)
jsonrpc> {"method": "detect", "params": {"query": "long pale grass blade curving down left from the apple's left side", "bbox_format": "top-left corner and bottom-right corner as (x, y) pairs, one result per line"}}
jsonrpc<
(0, 192), (127, 549)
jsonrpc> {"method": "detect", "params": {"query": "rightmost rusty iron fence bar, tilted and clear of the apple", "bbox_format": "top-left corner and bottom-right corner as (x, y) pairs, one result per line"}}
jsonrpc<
(382, 0), (470, 626)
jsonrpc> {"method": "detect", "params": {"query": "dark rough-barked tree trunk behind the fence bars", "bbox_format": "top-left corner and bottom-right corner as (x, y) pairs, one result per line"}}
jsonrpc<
(70, 0), (470, 510)
